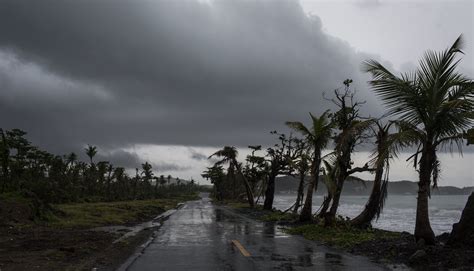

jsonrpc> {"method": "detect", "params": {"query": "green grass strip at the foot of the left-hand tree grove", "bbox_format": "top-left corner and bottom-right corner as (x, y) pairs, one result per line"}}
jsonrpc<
(0, 193), (199, 229)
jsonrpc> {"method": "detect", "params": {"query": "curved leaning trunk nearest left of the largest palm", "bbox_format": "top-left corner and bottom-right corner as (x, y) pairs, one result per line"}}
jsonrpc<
(351, 166), (383, 228)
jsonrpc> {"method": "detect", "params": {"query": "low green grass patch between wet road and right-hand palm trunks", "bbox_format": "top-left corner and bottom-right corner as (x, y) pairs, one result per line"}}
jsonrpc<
(286, 224), (400, 249)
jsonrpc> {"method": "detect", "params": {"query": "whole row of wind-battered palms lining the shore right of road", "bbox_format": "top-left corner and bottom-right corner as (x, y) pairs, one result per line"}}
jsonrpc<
(203, 37), (474, 244)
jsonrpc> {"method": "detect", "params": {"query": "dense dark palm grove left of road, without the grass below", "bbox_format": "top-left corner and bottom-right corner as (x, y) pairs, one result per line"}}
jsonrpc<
(0, 129), (198, 203)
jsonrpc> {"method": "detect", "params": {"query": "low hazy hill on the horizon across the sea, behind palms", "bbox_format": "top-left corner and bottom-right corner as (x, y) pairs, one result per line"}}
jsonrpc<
(275, 176), (474, 196)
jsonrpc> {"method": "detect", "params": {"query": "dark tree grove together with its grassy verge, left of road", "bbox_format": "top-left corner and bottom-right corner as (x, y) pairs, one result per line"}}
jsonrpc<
(0, 129), (205, 227)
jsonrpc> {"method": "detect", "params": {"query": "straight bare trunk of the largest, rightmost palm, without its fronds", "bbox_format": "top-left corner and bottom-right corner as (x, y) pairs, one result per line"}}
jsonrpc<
(415, 146), (435, 245)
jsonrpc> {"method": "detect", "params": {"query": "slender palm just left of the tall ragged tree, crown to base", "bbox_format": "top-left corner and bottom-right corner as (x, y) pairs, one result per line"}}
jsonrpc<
(286, 111), (333, 221)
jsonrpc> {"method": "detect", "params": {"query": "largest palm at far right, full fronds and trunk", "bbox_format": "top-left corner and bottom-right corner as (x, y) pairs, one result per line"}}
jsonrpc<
(364, 36), (474, 244)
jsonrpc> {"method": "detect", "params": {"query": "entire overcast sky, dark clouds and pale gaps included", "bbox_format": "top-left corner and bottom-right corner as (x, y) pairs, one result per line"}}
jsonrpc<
(0, 0), (474, 186)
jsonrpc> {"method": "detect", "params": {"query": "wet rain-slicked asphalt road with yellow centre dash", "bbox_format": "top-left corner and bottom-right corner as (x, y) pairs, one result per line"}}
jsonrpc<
(127, 198), (384, 271)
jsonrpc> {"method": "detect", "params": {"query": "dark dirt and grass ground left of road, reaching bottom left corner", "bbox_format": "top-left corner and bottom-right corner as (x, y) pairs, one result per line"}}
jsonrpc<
(0, 195), (196, 271)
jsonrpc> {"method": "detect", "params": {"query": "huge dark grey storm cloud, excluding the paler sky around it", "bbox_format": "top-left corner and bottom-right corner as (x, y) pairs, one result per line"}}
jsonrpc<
(0, 0), (384, 154)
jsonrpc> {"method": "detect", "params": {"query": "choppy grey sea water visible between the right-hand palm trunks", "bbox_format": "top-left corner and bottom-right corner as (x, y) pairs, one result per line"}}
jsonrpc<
(274, 194), (469, 235)
